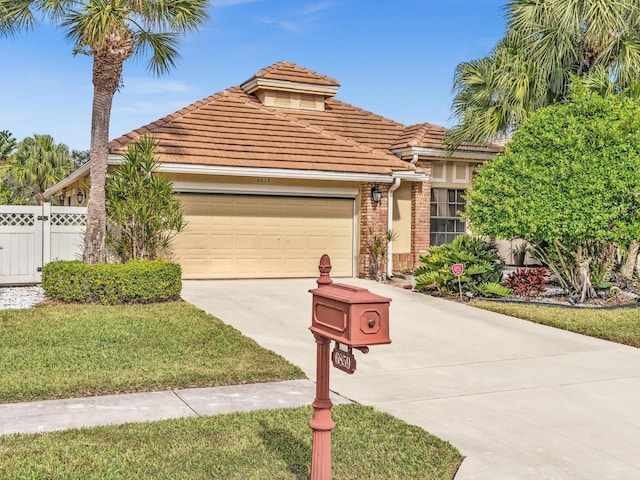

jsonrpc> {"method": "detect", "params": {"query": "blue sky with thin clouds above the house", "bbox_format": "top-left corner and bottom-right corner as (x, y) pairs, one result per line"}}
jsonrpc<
(0, 0), (506, 149)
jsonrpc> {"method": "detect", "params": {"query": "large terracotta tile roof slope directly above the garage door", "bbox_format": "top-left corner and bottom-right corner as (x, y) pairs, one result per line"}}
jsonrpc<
(109, 87), (415, 174)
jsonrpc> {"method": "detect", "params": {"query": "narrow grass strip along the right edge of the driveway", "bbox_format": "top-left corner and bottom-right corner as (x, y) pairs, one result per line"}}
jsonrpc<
(472, 300), (640, 347)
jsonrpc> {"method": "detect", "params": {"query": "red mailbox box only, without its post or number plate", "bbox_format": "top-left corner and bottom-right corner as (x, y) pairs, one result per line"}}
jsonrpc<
(309, 283), (391, 347)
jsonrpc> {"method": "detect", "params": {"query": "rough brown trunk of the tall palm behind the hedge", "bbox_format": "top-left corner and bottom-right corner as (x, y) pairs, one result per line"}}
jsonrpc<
(84, 31), (133, 263)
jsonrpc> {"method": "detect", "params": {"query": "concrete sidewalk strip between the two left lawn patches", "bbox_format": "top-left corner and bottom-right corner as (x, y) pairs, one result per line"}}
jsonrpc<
(0, 380), (350, 435)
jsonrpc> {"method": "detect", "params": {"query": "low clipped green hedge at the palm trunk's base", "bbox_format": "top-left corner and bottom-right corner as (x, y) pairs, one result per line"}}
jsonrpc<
(42, 260), (182, 305)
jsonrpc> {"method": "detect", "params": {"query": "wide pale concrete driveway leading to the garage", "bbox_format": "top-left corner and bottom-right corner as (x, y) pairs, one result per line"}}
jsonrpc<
(182, 279), (640, 480)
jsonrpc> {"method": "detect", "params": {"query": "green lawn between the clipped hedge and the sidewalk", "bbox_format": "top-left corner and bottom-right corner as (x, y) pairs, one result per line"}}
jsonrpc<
(0, 302), (305, 403)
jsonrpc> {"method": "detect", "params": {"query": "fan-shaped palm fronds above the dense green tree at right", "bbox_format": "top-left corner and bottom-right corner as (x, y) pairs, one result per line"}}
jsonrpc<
(447, 0), (640, 148)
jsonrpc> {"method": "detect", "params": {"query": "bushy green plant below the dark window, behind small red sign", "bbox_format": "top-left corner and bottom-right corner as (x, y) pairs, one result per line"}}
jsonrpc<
(414, 235), (510, 297)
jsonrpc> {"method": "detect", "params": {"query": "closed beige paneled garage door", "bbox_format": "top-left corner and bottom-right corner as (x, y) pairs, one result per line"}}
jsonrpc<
(174, 194), (353, 279)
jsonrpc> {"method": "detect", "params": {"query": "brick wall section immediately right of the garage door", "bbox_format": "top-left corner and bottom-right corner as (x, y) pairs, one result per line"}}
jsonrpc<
(358, 183), (389, 278)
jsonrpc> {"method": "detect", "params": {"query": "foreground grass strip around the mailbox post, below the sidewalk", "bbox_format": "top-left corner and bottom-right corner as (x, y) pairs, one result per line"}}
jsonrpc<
(0, 404), (462, 480)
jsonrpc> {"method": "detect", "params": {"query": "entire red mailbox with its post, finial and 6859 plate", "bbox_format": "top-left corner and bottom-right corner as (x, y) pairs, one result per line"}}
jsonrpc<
(309, 254), (391, 480)
